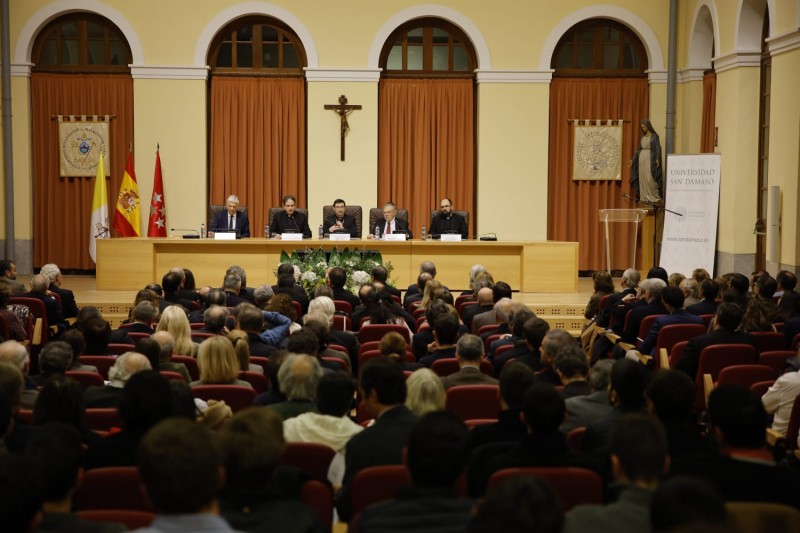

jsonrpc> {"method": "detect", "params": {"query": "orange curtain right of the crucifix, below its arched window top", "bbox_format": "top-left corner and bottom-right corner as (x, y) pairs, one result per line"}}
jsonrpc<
(376, 79), (475, 237)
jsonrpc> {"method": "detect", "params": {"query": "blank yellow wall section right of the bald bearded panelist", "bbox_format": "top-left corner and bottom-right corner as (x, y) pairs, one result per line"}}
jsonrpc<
(476, 83), (549, 240)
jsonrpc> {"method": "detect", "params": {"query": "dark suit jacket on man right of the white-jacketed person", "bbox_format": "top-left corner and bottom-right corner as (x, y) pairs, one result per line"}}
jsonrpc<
(336, 405), (419, 520)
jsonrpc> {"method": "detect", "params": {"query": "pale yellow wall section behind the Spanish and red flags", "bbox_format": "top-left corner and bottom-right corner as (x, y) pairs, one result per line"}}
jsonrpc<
(133, 79), (208, 235)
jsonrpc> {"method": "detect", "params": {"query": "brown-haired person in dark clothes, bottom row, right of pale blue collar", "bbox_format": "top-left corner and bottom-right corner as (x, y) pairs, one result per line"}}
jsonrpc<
(214, 409), (324, 533)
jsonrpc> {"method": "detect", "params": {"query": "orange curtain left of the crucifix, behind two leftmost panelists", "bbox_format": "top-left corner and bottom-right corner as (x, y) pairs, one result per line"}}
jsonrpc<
(209, 76), (307, 235)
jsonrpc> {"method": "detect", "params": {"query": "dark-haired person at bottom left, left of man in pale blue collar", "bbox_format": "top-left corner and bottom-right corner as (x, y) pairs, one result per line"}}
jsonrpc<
(27, 423), (127, 533)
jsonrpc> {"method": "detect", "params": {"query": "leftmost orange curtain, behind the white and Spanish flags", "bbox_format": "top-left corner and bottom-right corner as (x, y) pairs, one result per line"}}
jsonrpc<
(31, 73), (133, 270)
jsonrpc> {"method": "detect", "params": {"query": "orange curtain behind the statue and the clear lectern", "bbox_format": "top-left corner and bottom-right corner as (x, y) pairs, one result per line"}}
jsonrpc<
(547, 78), (652, 270)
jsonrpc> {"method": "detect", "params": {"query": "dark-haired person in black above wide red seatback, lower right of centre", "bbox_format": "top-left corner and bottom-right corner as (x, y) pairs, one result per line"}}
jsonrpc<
(468, 383), (599, 496)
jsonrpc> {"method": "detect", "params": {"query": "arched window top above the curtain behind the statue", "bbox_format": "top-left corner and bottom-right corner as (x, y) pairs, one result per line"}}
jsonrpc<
(551, 19), (647, 78)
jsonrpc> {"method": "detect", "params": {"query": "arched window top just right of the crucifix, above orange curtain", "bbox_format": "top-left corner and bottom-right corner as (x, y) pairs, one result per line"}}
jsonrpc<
(380, 19), (477, 78)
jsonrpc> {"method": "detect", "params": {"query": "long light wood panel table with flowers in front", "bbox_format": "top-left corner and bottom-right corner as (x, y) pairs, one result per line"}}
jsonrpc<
(97, 238), (578, 292)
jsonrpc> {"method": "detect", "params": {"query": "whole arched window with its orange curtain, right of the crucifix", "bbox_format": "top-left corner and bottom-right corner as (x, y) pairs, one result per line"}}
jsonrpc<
(376, 18), (477, 235)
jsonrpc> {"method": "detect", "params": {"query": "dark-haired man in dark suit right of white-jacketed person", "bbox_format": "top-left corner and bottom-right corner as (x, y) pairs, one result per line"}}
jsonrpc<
(336, 358), (418, 520)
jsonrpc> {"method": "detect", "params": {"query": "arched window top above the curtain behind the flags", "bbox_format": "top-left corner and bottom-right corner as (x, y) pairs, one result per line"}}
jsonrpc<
(32, 13), (132, 74)
